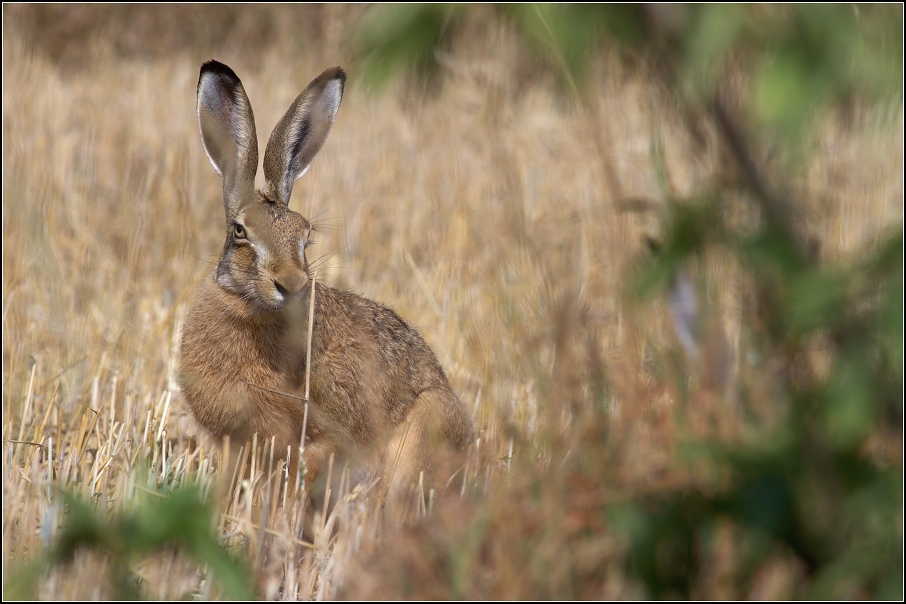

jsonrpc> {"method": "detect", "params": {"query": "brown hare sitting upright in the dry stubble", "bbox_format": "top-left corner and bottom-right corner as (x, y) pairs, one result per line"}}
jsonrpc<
(179, 61), (473, 502)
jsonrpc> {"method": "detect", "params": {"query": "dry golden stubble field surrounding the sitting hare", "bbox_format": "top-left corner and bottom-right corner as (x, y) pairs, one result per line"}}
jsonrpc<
(2, 5), (903, 599)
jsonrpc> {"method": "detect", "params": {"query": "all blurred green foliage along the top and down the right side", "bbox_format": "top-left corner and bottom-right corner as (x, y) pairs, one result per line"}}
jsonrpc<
(352, 4), (903, 599)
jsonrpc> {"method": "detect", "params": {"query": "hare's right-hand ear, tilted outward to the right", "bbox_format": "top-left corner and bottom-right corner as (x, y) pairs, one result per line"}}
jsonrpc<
(264, 67), (346, 205)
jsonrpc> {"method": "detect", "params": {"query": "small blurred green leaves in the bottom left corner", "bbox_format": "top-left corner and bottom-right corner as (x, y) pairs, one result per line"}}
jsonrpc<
(4, 486), (253, 600)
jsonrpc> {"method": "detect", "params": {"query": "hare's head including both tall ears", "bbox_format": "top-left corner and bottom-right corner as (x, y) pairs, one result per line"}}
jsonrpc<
(198, 61), (346, 311)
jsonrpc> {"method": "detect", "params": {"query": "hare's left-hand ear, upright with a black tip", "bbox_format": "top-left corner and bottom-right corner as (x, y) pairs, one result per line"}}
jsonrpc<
(197, 61), (258, 220)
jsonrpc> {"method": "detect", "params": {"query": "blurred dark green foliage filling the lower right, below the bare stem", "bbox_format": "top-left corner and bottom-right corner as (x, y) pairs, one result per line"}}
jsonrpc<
(632, 185), (903, 599)
